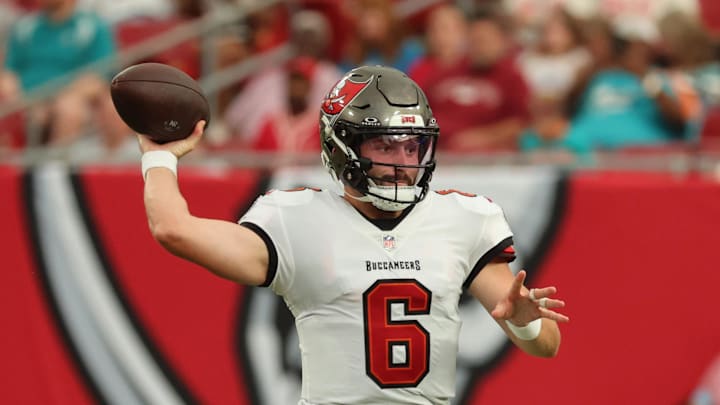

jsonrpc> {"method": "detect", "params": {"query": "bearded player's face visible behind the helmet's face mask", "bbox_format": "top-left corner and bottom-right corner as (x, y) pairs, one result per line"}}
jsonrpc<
(360, 135), (422, 186)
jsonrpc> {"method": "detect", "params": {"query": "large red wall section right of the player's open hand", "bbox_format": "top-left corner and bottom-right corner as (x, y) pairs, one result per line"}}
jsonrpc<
(473, 173), (720, 405)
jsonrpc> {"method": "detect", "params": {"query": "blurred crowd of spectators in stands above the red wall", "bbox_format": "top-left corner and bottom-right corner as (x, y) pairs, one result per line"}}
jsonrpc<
(0, 0), (720, 159)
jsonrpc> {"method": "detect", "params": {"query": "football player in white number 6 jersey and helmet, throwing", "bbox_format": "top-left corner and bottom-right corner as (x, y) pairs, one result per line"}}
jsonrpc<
(138, 66), (568, 405)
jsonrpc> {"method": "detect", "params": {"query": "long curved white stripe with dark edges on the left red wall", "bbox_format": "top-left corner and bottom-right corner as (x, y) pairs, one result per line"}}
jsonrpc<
(26, 164), (196, 405)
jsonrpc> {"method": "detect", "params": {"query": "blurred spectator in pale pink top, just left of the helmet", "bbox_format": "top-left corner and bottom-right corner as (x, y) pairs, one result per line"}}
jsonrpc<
(223, 10), (341, 145)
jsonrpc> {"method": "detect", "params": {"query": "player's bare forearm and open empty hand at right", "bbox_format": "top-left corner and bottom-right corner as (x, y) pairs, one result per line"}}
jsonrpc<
(469, 262), (570, 357)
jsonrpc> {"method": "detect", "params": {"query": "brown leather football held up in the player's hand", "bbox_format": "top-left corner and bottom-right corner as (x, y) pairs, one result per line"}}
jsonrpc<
(110, 63), (210, 143)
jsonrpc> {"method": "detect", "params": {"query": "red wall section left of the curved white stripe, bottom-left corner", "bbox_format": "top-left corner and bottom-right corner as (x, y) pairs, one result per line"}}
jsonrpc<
(0, 167), (92, 405)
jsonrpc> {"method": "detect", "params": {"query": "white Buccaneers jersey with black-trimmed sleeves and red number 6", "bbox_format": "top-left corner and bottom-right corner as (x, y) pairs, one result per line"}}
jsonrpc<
(240, 189), (512, 405)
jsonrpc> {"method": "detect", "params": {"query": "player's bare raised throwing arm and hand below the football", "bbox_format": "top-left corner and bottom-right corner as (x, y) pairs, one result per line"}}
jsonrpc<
(138, 121), (269, 285)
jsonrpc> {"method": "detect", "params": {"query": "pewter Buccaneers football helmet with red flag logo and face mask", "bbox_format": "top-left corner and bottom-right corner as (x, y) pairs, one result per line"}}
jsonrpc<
(320, 66), (440, 211)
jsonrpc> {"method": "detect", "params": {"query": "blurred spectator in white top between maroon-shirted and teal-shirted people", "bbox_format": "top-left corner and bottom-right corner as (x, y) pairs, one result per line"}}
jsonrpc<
(518, 7), (591, 139)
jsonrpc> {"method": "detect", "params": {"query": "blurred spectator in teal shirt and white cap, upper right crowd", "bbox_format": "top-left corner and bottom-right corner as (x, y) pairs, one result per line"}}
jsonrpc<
(562, 16), (687, 152)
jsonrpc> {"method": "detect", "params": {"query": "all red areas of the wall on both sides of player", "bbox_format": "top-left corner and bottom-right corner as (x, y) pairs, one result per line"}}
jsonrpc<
(0, 167), (720, 405)
